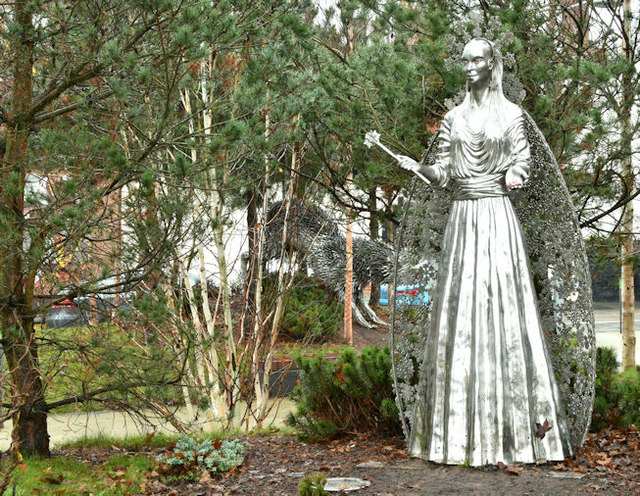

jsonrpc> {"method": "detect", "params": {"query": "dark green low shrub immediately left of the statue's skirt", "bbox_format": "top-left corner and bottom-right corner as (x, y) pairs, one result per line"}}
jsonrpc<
(287, 347), (401, 440)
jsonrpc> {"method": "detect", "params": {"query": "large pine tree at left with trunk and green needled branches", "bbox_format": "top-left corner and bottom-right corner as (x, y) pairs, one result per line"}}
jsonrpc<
(0, 0), (312, 455)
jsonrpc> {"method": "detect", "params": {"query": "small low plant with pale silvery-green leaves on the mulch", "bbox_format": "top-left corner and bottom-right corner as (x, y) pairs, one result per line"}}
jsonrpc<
(156, 437), (246, 483)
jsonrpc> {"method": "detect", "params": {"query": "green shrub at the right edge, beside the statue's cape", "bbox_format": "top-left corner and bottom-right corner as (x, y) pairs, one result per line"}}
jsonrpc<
(590, 348), (640, 432)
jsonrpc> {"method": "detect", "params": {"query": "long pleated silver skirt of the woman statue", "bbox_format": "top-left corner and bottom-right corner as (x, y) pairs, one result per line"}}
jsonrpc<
(409, 196), (571, 466)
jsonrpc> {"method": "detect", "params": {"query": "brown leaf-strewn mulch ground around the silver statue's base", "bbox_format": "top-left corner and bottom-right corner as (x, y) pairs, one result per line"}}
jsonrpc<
(59, 428), (640, 496)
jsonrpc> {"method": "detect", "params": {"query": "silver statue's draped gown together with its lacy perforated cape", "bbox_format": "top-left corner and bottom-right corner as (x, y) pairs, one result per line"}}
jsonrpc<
(394, 104), (595, 465)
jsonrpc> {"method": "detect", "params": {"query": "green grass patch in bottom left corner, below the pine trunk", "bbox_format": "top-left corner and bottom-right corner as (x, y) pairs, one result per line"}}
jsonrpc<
(0, 455), (154, 496)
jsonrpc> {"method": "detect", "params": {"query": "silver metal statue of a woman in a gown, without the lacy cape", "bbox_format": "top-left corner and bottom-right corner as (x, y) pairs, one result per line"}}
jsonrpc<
(380, 39), (572, 466)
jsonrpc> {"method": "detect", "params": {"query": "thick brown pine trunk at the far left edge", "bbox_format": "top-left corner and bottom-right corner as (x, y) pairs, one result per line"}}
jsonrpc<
(0, 2), (49, 458)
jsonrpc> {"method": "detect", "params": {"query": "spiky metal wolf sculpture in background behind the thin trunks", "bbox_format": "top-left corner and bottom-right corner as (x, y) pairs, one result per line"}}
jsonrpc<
(265, 201), (391, 328)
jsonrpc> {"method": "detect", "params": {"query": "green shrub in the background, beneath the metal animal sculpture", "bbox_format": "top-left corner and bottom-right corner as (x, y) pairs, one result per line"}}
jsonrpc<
(265, 275), (343, 340)
